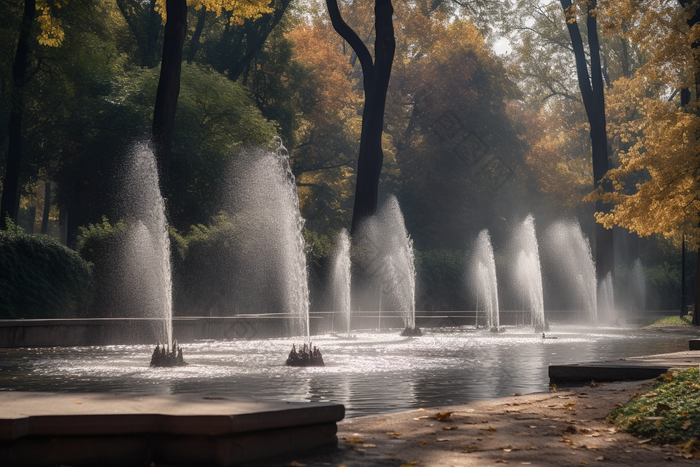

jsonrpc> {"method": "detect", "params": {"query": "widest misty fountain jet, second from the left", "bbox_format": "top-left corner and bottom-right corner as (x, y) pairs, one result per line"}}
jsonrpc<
(224, 137), (310, 340)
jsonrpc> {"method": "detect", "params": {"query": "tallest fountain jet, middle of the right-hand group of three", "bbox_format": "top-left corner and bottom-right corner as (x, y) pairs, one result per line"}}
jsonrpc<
(513, 214), (547, 332)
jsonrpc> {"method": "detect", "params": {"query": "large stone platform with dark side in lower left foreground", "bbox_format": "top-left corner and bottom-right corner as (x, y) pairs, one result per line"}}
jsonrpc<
(0, 391), (345, 467)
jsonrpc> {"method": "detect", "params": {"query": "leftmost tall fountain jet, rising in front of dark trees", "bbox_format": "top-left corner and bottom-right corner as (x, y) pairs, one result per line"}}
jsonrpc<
(120, 143), (173, 349)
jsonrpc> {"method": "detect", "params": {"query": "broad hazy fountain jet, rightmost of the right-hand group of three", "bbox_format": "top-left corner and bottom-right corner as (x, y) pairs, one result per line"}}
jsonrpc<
(545, 220), (598, 325)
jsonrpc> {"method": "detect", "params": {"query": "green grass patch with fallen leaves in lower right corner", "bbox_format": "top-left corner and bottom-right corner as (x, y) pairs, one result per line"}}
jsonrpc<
(608, 368), (700, 458)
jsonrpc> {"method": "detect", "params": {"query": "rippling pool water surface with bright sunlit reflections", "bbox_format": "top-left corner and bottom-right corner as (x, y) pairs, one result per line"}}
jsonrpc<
(0, 327), (688, 416)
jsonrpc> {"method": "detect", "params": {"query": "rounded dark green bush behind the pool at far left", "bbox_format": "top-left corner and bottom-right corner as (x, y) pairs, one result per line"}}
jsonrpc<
(0, 219), (92, 319)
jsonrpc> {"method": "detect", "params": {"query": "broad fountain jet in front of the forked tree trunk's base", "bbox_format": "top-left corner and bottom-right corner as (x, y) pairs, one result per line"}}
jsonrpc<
(357, 196), (420, 336)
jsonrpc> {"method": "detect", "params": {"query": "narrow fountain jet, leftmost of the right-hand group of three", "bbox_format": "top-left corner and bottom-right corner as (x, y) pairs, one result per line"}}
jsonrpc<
(471, 229), (499, 330)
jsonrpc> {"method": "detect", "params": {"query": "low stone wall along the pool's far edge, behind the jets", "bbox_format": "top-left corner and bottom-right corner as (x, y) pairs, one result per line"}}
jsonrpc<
(0, 310), (677, 348)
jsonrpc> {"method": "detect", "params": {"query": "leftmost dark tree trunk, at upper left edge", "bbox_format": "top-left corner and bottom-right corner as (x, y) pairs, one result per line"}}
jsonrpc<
(0, 0), (36, 229)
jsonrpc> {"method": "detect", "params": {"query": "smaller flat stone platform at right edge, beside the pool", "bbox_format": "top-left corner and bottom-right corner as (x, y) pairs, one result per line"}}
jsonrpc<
(549, 350), (700, 384)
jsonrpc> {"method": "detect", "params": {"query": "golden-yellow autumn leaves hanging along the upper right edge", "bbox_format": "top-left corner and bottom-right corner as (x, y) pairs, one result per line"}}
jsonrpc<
(586, 0), (700, 248)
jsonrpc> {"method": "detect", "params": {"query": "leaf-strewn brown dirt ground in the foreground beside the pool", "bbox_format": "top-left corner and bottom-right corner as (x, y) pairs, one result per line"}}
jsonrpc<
(250, 382), (700, 467)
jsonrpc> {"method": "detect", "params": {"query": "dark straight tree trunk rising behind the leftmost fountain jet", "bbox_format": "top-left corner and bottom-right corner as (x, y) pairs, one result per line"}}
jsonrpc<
(153, 0), (187, 187)
